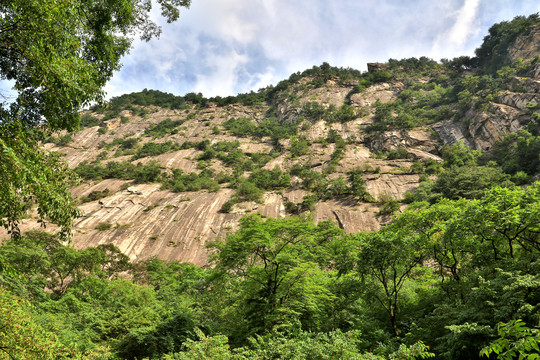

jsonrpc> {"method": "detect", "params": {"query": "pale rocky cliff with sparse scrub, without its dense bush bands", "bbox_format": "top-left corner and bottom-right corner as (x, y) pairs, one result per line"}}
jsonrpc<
(5, 21), (540, 265)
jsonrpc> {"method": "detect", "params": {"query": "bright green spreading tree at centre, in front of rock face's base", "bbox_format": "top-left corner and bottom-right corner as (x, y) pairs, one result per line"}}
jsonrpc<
(212, 216), (343, 338)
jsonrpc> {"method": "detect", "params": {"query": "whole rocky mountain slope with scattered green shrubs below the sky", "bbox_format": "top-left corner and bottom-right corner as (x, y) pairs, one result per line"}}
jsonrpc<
(8, 16), (540, 265)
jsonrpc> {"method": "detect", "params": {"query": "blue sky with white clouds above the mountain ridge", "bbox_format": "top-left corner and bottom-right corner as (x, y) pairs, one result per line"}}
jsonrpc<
(105, 0), (540, 98)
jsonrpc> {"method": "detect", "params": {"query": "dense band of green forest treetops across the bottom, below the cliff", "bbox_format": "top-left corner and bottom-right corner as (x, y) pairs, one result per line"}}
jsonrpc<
(0, 184), (540, 360)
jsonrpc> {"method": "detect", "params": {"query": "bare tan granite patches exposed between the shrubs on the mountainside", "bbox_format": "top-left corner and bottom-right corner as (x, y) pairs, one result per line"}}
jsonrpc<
(7, 27), (540, 265)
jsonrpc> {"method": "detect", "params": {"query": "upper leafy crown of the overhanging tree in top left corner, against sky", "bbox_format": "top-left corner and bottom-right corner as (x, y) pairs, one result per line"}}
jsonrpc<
(0, 0), (190, 130)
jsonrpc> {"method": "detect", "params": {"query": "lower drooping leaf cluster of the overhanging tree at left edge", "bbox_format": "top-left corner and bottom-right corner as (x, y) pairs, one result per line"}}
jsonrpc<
(0, 125), (79, 237)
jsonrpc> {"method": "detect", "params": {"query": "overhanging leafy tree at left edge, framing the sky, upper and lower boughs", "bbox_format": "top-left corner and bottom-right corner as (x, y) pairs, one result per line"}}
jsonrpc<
(0, 0), (191, 236)
